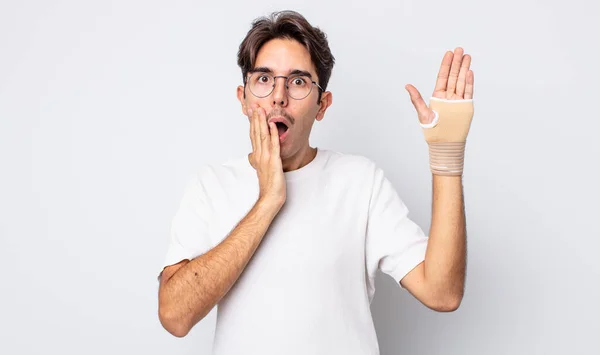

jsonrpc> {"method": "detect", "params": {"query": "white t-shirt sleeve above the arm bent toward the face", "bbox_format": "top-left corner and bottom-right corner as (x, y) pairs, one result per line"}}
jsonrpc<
(159, 171), (213, 277)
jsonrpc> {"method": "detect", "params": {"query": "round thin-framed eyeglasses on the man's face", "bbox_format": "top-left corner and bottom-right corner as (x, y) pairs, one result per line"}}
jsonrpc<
(247, 72), (324, 100)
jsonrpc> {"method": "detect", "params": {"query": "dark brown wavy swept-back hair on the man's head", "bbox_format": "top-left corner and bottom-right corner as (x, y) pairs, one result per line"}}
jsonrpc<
(238, 10), (335, 103)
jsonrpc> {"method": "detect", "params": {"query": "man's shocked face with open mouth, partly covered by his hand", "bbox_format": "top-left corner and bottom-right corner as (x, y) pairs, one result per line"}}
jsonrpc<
(237, 39), (331, 159)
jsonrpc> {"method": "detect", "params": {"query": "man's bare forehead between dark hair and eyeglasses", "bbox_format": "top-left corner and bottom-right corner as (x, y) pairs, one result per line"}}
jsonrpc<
(254, 38), (317, 77)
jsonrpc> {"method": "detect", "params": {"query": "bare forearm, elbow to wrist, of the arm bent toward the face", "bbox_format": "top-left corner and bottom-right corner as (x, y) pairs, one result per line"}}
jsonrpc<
(159, 200), (280, 335)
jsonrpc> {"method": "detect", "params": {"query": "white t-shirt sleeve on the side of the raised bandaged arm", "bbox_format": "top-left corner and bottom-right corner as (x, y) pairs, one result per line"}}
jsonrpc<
(366, 168), (428, 285)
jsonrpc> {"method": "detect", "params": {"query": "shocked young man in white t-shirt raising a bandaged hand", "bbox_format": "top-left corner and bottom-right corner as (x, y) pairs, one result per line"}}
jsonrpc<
(159, 12), (473, 355)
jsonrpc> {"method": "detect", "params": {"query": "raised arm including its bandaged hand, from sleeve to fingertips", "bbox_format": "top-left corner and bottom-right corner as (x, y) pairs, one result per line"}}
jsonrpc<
(401, 47), (474, 311)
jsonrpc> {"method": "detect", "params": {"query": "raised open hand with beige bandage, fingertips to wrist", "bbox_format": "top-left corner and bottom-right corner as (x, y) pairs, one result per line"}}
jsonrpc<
(406, 48), (474, 176)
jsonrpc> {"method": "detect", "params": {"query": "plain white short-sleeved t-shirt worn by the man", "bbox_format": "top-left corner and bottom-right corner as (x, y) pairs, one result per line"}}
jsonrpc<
(163, 149), (428, 355)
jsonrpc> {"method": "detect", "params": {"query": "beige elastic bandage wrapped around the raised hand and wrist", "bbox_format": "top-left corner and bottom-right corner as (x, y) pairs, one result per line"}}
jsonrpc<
(421, 97), (474, 176)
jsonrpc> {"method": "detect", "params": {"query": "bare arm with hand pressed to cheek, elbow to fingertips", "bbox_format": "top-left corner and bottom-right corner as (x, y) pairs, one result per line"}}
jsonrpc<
(158, 106), (286, 337)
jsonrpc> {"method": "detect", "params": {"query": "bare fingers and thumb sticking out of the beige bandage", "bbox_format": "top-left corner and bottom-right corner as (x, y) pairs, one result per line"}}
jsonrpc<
(406, 47), (474, 124)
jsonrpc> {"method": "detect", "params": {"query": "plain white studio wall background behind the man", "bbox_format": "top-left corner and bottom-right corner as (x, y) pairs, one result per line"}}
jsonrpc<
(0, 0), (600, 355)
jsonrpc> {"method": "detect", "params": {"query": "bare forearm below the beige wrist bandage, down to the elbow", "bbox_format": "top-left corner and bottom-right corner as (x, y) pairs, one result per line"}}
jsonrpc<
(425, 175), (467, 303)
